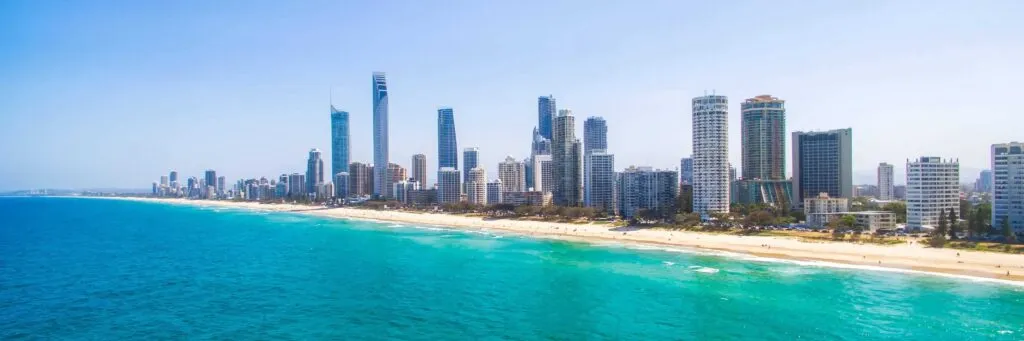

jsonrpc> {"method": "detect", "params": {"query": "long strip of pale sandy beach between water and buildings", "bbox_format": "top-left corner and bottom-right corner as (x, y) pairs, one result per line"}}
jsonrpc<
(105, 198), (1024, 283)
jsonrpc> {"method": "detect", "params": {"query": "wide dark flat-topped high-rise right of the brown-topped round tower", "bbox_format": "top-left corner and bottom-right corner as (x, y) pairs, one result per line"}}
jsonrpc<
(793, 128), (853, 205)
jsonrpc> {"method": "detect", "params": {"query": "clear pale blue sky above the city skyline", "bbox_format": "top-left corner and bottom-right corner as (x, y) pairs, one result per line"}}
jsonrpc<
(0, 0), (1024, 190)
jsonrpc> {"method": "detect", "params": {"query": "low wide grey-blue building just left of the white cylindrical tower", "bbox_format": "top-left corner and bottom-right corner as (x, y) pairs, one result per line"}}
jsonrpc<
(616, 167), (679, 219)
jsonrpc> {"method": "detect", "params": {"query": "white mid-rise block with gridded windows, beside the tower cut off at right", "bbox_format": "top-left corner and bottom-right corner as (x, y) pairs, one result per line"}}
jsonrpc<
(906, 157), (958, 230)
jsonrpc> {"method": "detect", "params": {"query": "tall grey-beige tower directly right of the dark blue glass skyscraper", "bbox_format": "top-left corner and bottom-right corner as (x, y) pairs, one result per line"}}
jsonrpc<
(551, 110), (583, 206)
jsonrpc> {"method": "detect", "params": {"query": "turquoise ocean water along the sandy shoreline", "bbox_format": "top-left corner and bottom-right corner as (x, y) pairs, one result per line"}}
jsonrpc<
(0, 195), (1024, 340)
